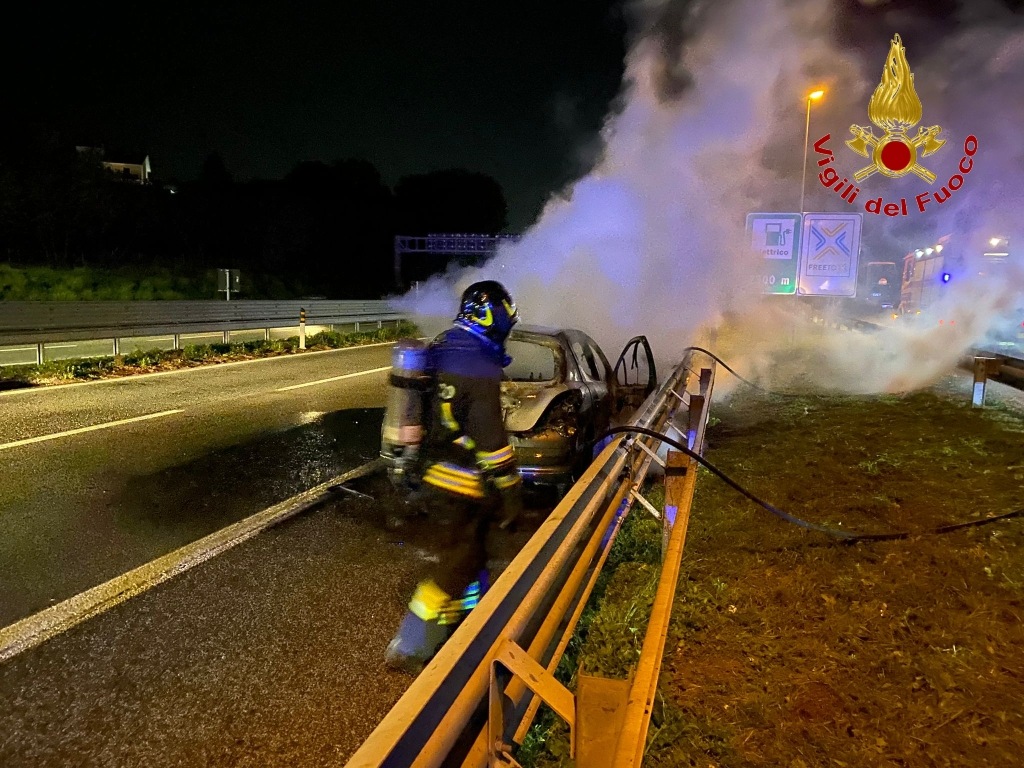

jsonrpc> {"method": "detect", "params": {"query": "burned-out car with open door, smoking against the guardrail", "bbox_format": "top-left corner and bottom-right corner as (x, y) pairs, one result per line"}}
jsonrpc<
(502, 326), (657, 488)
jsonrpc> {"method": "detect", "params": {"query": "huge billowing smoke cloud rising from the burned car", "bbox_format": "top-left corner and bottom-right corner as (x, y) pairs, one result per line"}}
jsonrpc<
(399, 0), (1024, 392)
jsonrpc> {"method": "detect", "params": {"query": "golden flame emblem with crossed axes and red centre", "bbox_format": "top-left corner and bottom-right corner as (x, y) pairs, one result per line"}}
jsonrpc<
(846, 35), (946, 184)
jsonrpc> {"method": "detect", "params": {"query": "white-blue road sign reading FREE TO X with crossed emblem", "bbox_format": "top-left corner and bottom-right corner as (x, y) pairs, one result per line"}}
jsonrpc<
(798, 213), (863, 296)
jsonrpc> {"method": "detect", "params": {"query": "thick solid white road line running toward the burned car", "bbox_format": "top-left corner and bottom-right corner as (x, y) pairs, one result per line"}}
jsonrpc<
(0, 459), (384, 663)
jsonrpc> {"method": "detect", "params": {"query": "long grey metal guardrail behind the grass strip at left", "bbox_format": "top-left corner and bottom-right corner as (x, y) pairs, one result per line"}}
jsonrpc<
(0, 299), (406, 365)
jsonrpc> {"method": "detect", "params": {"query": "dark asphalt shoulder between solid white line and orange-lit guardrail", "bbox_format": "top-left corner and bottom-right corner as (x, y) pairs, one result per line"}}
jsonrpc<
(0, 456), (552, 768)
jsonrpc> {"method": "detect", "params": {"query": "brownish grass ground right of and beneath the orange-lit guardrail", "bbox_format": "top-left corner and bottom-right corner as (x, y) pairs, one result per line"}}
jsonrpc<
(520, 380), (1024, 768)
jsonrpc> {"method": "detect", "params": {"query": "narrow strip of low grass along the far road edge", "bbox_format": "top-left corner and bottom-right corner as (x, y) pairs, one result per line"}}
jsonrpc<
(0, 321), (420, 389)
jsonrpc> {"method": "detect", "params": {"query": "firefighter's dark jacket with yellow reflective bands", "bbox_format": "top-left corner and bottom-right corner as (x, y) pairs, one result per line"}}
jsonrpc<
(423, 327), (521, 501)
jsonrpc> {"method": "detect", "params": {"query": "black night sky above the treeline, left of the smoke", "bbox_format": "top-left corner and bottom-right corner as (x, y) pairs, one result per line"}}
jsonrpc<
(3, 0), (627, 230)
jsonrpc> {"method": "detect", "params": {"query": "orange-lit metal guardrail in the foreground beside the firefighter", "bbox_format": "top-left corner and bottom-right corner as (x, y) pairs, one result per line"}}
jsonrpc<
(347, 353), (714, 768)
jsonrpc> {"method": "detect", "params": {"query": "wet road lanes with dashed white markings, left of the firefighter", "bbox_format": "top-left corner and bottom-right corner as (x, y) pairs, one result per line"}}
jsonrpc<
(0, 342), (391, 627)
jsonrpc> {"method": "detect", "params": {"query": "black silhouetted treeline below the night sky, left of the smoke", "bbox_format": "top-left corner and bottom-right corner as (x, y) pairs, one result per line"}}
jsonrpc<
(0, 130), (508, 299)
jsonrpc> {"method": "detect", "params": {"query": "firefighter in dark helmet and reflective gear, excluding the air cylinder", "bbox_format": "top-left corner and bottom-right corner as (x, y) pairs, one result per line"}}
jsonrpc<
(386, 281), (522, 674)
